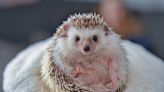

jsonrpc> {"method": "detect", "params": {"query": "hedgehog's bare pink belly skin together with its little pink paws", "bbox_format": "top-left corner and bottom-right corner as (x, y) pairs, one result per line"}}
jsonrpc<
(71, 57), (119, 92)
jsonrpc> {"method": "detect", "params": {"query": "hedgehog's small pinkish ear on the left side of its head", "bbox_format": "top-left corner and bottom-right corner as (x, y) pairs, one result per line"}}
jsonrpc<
(58, 24), (70, 37)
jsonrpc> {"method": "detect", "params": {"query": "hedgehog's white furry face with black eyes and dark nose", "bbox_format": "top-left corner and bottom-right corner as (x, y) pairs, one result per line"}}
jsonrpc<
(67, 27), (110, 54)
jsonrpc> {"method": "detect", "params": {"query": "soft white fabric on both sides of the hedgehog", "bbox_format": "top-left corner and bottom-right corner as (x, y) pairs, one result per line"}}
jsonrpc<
(3, 38), (164, 92)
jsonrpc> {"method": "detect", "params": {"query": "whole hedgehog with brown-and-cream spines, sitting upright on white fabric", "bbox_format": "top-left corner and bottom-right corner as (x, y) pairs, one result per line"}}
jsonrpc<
(41, 13), (128, 92)
